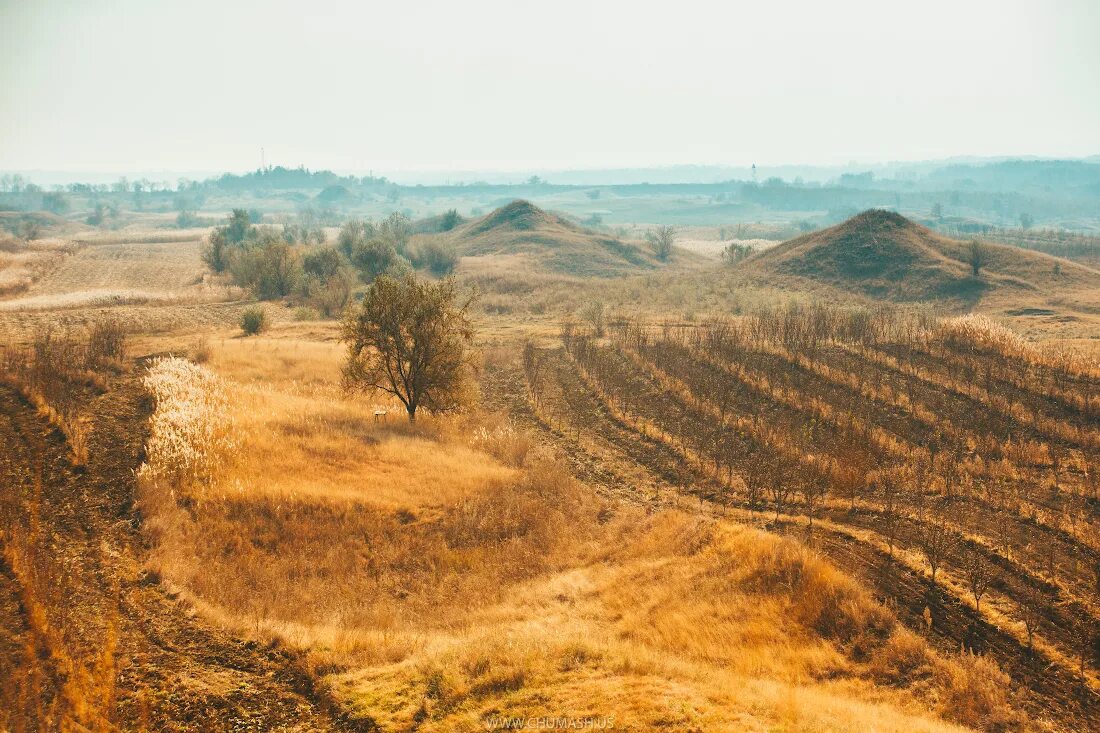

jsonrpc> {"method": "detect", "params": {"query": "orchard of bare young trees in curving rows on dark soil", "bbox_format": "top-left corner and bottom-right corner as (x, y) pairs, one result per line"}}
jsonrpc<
(545, 305), (1100, 669)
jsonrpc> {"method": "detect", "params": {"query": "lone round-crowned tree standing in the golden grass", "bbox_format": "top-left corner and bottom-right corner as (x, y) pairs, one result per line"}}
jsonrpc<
(342, 275), (473, 423)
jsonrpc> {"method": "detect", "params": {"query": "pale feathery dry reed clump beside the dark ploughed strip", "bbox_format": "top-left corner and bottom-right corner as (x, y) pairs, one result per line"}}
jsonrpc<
(138, 357), (237, 492)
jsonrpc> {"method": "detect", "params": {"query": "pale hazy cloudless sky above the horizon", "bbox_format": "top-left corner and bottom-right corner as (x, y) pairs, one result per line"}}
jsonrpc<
(0, 0), (1100, 174)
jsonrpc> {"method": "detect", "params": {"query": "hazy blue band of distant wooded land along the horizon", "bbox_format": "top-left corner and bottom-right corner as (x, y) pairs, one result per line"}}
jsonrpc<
(0, 161), (1100, 230)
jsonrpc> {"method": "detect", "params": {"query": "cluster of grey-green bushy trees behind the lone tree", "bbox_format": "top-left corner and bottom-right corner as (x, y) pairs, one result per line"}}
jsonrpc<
(202, 209), (458, 317)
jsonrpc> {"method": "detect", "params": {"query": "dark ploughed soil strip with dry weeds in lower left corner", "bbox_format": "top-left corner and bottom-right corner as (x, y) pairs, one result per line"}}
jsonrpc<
(0, 376), (354, 731)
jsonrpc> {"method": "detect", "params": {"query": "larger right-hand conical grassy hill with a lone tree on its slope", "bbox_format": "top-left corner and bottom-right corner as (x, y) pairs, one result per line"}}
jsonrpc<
(745, 209), (1100, 305)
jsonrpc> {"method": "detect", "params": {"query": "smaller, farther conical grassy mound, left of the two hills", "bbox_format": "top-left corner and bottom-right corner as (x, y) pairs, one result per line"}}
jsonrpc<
(443, 200), (658, 277)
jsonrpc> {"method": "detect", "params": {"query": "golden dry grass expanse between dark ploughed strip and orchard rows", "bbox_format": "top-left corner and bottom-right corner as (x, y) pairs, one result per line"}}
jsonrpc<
(133, 332), (1025, 731)
